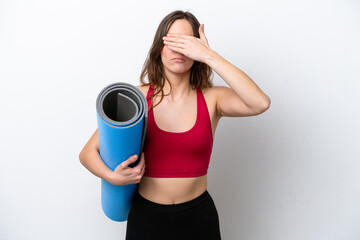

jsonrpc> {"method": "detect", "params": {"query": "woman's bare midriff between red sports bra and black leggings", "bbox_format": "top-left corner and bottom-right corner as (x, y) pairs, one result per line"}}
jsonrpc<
(138, 175), (207, 204)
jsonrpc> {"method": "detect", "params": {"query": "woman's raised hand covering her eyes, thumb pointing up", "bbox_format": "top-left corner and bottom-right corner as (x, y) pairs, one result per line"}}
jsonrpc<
(163, 24), (211, 62)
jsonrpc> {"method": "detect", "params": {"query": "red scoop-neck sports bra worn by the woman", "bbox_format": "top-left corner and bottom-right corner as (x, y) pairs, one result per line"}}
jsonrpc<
(143, 85), (213, 178)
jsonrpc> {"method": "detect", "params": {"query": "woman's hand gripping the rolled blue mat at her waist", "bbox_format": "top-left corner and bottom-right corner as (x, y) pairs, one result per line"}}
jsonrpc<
(110, 152), (145, 185)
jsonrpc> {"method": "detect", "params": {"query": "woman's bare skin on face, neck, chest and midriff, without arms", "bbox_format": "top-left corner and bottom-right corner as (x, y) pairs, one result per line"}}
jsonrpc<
(137, 19), (220, 204)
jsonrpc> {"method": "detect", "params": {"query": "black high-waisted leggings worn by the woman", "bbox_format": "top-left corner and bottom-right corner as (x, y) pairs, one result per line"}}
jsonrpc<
(125, 190), (221, 240)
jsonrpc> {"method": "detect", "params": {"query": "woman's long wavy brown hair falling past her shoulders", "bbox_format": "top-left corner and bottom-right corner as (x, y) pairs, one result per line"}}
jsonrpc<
(140, 10), (213, 110)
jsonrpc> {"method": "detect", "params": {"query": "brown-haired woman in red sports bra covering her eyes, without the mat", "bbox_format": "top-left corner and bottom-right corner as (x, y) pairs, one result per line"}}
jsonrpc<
(80, 11), (270, 240)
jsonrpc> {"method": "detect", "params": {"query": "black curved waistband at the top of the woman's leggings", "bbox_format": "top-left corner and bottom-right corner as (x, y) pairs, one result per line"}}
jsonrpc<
(132, 189), (210, 212)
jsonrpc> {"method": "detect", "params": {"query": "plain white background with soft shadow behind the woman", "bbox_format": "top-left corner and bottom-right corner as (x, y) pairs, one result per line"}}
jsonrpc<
(0, 0), (360, 240)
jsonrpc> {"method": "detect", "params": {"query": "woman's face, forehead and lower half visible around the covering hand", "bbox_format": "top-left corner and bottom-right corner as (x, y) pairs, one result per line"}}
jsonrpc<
(161, 19), (194, 76)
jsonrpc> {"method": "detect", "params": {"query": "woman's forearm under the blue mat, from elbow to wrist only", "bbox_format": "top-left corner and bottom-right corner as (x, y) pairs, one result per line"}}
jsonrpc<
(79, 149), (113, 182)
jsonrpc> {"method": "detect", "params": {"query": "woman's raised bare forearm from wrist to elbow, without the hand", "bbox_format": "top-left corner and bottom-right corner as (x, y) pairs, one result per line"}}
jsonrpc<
(205, 50), (270, 108)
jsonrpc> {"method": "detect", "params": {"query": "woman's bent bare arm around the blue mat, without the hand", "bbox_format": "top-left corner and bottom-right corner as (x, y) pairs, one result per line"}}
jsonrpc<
(79, 129), (113, 183)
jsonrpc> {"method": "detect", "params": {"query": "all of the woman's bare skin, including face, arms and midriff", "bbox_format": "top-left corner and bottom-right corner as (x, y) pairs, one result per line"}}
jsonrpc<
(79, 19), (270, 204)
